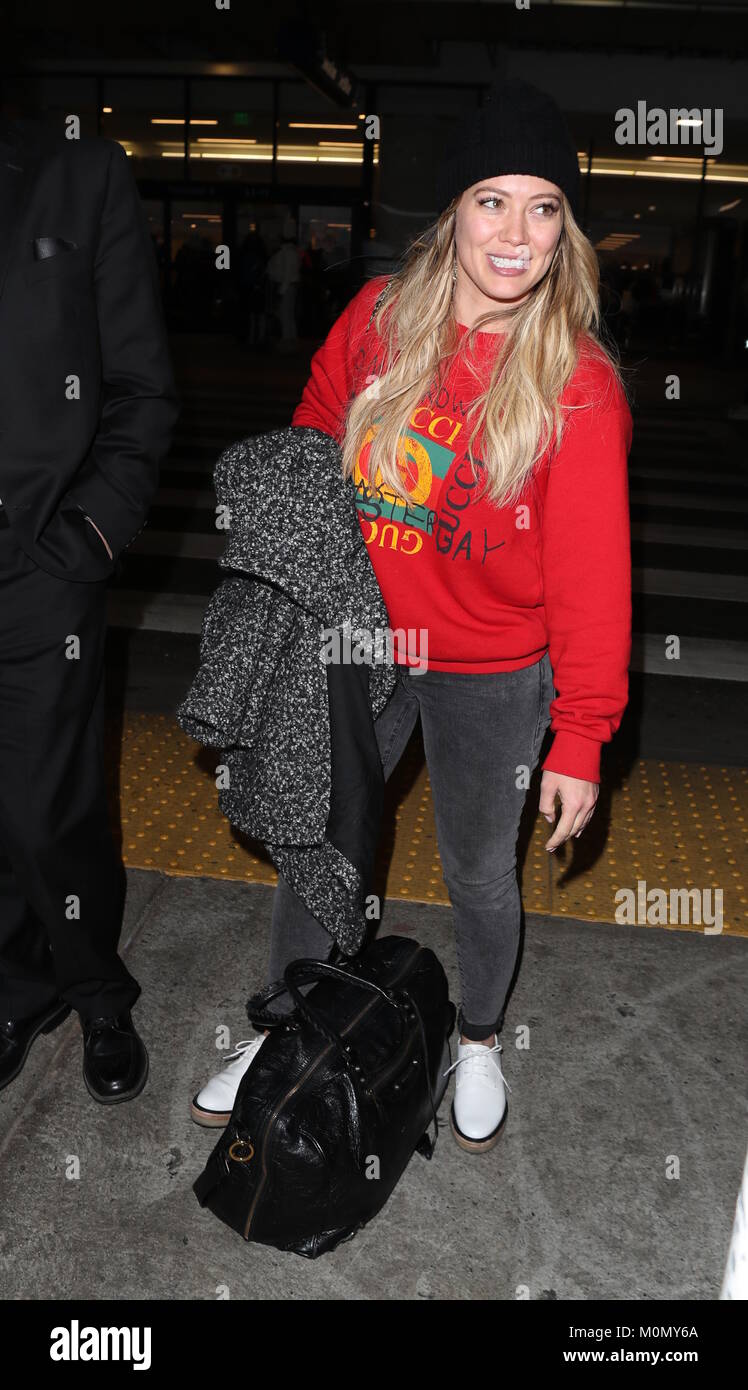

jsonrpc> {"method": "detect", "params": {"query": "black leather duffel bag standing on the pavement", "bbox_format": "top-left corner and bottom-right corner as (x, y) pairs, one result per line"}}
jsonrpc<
(193, 937), (456, 1259)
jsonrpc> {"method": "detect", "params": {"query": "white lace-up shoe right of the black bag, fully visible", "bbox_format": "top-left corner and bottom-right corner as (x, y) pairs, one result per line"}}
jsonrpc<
(445, 1043), (512, 1154)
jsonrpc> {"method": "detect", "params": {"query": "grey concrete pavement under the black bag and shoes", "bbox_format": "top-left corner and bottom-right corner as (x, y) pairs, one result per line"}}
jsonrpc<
(0, 870), (745, 1300)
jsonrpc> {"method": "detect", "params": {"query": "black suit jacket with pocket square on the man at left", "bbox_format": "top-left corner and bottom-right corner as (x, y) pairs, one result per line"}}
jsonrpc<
(0, 114), (179, 581)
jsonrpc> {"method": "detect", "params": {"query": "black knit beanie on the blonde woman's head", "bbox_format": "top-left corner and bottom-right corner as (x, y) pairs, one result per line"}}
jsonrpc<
(437, 78), (580, 217)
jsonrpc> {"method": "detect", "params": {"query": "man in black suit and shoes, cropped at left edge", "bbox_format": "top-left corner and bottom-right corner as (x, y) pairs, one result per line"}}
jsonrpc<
(0, 110), (179, 1104)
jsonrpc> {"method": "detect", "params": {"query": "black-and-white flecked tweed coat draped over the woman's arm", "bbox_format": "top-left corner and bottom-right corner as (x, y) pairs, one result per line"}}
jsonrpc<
(177, 425), (395, 954)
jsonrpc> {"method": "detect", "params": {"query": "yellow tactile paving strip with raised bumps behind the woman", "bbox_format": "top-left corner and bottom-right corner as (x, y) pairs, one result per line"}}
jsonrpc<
(111, 713), (748, 935)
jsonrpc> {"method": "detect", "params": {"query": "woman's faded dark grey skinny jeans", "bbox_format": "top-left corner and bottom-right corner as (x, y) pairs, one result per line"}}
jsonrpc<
(268, 653), (555, 1040)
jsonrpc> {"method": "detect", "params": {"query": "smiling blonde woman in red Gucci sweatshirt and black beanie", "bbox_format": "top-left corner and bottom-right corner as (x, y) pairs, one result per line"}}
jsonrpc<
(192, 82), (631, 1152)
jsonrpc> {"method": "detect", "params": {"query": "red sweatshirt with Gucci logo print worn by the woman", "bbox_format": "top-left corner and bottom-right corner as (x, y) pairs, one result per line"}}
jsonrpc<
(292, 275), (633, 781)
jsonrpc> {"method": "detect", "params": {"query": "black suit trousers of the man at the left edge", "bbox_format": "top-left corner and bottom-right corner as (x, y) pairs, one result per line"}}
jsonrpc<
(0, 510), (140, 1017)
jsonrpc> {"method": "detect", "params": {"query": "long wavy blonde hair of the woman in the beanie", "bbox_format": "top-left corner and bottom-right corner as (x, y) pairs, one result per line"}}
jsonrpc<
(342, 195), (624, 506)
